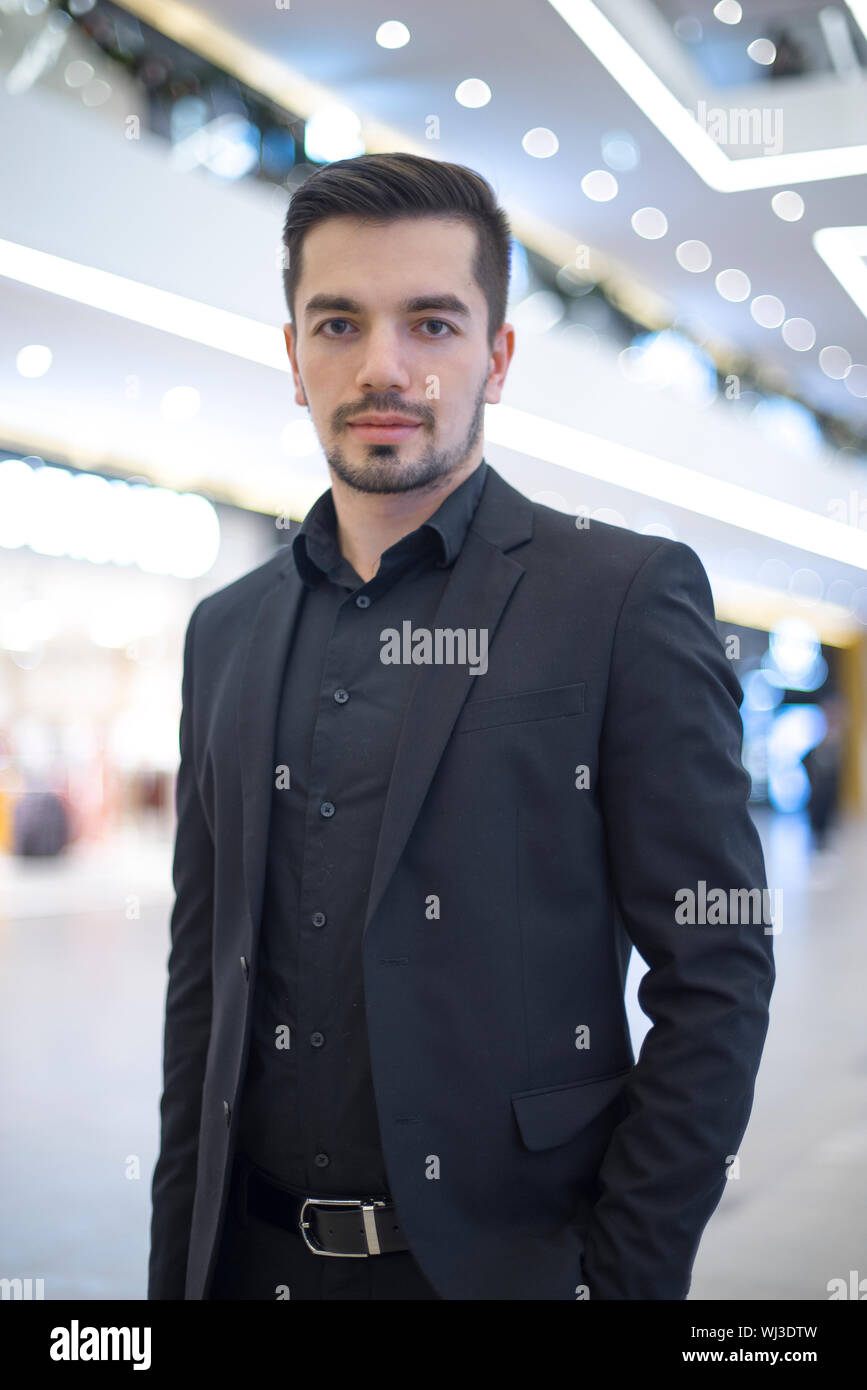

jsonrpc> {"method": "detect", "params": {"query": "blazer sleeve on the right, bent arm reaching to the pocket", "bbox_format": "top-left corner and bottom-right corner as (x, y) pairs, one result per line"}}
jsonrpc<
(584, 541), (775, 1300)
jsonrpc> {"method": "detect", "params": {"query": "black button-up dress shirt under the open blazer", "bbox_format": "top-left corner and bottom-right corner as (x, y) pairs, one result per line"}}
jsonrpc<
(238, 459), (488, 1197)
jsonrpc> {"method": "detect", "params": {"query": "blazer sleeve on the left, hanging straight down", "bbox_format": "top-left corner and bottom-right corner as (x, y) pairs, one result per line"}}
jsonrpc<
(147, 605), (214, 1300)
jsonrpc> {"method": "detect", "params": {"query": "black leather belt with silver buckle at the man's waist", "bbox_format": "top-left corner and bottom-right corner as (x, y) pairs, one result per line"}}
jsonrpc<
(235, 1152), (410, 1258)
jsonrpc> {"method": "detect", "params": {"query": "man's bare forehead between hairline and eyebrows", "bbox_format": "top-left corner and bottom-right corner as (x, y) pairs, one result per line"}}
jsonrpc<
(299, 215), (484, 300)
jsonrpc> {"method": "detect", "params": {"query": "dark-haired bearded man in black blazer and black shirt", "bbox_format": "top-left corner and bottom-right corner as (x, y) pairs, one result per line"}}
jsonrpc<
(149, 154), (774, 1300)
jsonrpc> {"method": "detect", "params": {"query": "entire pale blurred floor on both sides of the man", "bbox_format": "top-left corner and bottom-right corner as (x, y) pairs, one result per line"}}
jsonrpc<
(0, 812), (867, 1300)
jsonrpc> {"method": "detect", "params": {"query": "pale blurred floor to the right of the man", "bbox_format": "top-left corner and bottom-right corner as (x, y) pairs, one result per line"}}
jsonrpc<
(689, 816), (867, 1300)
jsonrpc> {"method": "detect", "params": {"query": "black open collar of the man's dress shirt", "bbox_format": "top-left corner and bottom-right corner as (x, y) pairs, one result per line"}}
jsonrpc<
(292, 459), (488, 587)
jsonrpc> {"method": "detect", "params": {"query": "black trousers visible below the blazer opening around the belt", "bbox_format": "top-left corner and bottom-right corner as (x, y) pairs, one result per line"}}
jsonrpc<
(208, 1162), (439, 1302)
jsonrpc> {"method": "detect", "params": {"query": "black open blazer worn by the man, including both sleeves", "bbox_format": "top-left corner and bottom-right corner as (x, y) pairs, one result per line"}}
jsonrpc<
(149, 467), (774, 1300)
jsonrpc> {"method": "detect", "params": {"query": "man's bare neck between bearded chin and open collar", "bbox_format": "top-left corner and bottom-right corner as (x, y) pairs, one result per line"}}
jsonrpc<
(331, 455), (481, 584)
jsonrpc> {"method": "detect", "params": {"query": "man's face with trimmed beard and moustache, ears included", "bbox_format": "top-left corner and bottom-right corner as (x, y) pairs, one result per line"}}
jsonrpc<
(283, 217), (514, 492)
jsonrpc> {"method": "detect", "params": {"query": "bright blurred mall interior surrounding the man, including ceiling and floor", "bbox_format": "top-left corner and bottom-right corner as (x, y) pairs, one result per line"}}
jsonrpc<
(0, 0), (867, 1300)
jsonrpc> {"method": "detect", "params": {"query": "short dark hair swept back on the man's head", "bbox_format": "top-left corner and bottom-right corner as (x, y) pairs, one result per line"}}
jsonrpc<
(283, 152), (511, 348)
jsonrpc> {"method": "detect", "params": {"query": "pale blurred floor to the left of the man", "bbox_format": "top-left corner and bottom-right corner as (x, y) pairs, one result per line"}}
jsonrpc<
(0, 833), (171, 1300)
